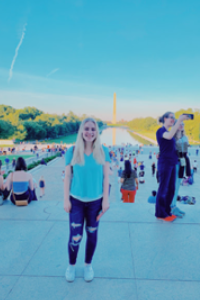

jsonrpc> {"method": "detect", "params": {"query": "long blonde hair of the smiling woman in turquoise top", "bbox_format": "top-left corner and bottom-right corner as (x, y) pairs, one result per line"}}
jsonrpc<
(71, 118), (105, 166)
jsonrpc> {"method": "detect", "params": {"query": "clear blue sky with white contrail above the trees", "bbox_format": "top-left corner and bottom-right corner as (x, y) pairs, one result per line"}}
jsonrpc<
(0, 0), (200, 120)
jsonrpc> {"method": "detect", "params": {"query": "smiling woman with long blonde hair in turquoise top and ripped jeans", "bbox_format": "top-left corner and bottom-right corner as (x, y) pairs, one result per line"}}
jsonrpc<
(64, 118), (111, 282)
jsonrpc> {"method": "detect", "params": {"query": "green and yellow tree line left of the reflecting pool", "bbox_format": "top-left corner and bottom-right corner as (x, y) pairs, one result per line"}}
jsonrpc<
(0, 105), (104, 141)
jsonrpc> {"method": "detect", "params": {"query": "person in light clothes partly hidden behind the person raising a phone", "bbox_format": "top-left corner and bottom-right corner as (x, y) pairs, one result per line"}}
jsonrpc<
(171, 122), (191, 218)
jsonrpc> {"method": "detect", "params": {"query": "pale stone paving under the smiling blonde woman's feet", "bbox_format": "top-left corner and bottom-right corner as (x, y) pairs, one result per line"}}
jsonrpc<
(0, 149), (200, 300)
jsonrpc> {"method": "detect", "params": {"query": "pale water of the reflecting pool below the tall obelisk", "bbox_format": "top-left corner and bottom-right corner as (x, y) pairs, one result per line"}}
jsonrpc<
(101, 128), (139, 145)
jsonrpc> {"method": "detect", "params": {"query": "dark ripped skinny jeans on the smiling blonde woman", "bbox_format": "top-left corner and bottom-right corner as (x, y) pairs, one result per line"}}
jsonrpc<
(68, 196), (102, 265)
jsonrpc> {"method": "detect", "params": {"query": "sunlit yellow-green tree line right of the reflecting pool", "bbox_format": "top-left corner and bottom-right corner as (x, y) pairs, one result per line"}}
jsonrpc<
(127, 108), (200, 142)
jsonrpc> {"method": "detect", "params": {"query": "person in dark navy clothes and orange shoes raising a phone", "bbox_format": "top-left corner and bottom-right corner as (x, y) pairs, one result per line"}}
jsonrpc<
(155, 112), (188, 222)
